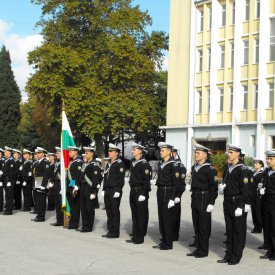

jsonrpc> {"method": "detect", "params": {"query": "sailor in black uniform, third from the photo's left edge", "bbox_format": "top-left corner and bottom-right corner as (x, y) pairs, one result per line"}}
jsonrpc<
(12, 149), (23, 210)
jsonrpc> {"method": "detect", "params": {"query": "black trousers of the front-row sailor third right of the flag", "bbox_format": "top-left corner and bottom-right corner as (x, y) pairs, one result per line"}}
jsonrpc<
(104, 188), (122, 237)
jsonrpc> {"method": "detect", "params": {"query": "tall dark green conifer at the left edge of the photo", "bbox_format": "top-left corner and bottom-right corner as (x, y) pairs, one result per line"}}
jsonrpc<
(0, 46), (21, 147)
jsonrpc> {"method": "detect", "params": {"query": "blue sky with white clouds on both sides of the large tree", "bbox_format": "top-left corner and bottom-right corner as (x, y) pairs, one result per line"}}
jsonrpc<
(0, 0), (170, 97)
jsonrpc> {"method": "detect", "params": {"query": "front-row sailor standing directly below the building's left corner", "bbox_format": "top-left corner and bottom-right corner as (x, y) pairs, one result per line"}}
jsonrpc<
(153, 142), (178, 250)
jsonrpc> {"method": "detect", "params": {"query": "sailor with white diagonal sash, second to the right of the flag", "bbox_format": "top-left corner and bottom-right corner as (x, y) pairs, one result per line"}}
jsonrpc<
(79, 147), (101, 232)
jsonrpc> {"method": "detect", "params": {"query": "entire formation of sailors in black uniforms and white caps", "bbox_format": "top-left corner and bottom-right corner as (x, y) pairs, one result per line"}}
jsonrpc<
(0, 142), (275, 265)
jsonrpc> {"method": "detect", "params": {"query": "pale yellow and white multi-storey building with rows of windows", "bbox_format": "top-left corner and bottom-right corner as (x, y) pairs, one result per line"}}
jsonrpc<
(161, 0), (275, 169)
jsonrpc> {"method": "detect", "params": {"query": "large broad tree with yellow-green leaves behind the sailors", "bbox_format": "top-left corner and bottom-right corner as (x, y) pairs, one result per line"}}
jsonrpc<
(26, 0), (168, 155)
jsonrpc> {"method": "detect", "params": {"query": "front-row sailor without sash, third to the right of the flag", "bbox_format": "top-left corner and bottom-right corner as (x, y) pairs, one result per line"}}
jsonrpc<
(101, 143), (125, 239)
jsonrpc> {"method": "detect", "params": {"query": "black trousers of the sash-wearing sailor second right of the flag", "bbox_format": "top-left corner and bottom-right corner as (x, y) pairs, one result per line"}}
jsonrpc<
(80, 183), (95, 231)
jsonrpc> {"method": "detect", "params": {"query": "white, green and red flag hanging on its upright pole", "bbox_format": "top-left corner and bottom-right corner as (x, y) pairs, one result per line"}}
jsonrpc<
(60, 111), (75, 221)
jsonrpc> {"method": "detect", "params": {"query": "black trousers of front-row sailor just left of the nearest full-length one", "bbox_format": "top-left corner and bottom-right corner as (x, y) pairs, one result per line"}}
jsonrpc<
(191, 192), (211, 256)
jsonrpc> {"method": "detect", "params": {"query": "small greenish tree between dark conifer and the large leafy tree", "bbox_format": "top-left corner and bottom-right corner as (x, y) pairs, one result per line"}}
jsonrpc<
(18, 102), (44, 150)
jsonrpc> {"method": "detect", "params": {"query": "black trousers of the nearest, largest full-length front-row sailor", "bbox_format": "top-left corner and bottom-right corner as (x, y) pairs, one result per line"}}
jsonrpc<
(223, 197), (247, 262)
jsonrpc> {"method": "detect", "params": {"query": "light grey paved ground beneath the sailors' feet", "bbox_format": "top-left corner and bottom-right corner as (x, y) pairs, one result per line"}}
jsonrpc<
(0, 186), (275, 275)
